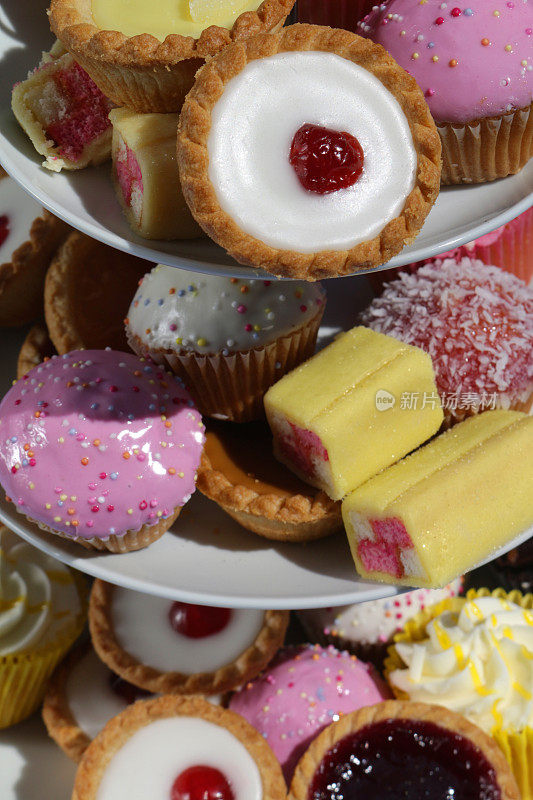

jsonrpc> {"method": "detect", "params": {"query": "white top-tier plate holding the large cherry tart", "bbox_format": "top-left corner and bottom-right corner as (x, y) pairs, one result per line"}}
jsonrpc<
(0, 0), (533, 277)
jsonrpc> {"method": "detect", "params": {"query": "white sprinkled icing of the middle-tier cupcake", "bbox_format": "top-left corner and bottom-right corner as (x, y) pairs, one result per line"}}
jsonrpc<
(126, 265), (326, 354)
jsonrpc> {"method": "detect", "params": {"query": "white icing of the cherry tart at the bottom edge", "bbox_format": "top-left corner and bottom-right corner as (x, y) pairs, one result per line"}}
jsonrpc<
(96, 717), (263, 800)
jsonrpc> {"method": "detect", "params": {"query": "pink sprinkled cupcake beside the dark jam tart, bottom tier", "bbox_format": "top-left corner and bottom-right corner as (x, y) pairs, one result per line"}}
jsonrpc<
(229, 645), (390, 783)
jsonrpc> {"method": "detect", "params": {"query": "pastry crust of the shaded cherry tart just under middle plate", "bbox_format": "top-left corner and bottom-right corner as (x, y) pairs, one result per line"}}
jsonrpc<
(89, 580), (289, 695)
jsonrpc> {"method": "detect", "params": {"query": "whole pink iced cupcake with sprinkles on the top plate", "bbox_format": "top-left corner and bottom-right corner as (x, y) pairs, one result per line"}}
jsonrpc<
(359, 0), (533, 184)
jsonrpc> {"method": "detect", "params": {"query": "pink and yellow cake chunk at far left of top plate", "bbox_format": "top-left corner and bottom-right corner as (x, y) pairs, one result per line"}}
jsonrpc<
(11, 42), (113, 172)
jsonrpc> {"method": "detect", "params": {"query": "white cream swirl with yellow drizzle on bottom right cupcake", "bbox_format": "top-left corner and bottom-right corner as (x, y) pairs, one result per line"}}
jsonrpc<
(389, 597), (533, 732)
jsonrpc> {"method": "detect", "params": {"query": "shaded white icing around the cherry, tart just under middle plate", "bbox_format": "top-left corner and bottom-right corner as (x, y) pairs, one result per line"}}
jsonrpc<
(111, 587), (265, 675)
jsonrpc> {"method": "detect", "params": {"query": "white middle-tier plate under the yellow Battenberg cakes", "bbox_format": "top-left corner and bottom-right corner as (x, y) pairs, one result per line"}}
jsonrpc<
(0, 322), (533, 608)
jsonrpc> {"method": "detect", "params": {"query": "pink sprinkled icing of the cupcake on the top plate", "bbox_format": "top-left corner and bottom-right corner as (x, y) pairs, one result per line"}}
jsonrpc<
(358, 0), (533, 123)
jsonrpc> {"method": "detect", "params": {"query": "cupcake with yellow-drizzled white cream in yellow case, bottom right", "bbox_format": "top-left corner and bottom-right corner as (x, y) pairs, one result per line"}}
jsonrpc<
(385, 589), (533, 800)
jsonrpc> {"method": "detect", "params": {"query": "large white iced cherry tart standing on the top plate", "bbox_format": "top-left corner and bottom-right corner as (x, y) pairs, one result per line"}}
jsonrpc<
(178, 25), (440, 280)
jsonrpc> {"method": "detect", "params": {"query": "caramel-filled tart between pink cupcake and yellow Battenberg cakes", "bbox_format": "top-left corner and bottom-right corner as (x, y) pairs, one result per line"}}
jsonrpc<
(196, 420), (342, 542)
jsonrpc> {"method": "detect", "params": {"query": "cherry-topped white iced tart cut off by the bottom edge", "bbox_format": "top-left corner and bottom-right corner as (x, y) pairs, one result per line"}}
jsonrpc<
(72, 695), (286, 800)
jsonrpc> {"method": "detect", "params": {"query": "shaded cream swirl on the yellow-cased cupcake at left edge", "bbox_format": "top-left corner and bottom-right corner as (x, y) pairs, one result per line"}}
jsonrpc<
(0, 527), (81, 657)
